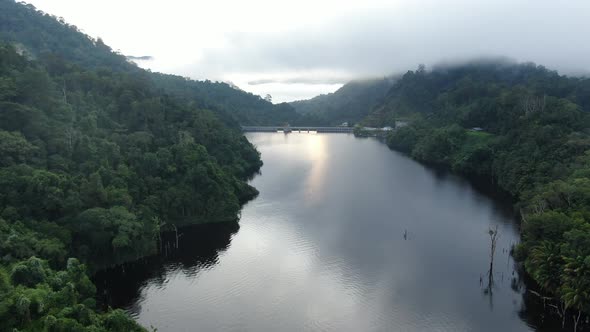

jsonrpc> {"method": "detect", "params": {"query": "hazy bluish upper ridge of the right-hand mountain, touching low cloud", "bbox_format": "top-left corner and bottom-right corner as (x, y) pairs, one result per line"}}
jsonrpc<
(363, 58), (590, 127)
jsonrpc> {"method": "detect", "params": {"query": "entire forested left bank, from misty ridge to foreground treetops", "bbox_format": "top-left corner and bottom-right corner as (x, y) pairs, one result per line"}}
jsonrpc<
(0, 0), (272, 331)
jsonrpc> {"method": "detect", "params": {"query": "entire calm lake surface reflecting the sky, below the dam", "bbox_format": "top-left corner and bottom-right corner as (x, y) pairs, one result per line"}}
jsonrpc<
(96, 133), (568, 332)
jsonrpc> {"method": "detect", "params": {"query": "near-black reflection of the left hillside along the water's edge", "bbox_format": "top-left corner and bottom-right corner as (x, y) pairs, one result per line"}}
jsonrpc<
(94, 223), (240, 316)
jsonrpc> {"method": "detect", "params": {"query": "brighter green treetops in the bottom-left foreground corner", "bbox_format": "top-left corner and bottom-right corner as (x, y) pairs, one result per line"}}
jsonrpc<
(0, 257), (144, 331)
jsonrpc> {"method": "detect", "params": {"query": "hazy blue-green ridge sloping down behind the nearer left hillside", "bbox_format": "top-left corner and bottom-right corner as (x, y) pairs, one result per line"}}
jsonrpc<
(0, 0), (299, 125)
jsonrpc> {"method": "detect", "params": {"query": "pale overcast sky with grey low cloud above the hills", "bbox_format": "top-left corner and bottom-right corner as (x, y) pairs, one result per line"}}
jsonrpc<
(28, 0), (590, 102)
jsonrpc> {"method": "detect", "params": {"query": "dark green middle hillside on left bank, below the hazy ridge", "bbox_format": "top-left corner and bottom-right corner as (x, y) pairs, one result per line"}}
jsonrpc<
(0, 29), (261, 265)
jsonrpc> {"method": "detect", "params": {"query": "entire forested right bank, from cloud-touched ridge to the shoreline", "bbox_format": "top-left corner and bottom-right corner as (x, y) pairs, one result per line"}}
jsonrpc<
(376, 62), (590, 319)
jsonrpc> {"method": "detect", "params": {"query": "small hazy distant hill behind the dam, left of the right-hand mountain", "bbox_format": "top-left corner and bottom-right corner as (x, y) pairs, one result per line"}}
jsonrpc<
(290, 77), (394, 125)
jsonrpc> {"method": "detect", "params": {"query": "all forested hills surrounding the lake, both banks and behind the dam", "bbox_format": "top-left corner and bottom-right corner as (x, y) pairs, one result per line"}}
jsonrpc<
(0, 0), (590, 331)
